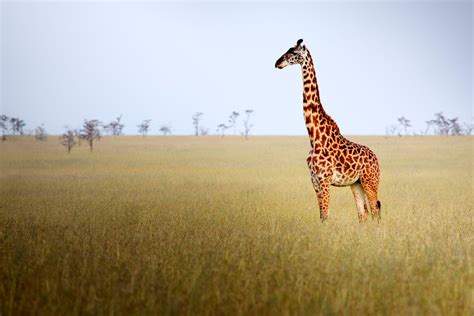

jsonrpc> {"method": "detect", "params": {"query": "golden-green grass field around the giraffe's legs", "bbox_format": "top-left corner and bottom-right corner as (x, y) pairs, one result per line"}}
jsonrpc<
(0, 137), (474, 316)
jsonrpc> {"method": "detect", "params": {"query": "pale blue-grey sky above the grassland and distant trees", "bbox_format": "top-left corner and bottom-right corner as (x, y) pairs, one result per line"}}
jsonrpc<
(0, 1), (473, 135)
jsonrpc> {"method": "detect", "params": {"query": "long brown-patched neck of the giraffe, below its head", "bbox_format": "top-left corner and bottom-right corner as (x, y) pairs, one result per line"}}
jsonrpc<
(301, 51), (337, 148)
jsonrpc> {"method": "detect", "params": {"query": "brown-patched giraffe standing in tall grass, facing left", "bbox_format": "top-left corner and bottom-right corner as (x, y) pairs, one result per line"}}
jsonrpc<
(275, 39), (381, 224)
